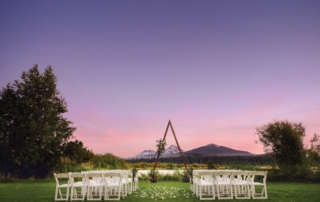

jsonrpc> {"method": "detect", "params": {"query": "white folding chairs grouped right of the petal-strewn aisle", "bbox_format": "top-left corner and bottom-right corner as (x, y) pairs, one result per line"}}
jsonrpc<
(192, 170), (267, 200)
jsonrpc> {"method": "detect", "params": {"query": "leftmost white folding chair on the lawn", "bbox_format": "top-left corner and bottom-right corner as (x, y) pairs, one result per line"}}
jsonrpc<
(54, 173), (71, 201)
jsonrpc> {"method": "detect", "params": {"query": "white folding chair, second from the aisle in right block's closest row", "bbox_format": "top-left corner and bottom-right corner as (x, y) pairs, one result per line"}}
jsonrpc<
(215, 170), (233, 199)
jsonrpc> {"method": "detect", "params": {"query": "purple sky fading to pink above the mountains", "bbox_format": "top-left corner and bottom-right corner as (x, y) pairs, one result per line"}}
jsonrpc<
(0, 0), (320, 157)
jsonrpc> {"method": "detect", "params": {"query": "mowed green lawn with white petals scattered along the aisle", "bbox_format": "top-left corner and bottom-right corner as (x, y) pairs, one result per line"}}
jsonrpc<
(0, 181), (320, 202)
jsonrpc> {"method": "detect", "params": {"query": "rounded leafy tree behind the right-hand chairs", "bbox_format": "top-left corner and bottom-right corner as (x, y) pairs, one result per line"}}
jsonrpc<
(256, 121), (307, 172)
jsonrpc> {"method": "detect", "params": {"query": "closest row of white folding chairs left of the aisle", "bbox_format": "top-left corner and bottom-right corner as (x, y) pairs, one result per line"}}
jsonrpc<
(54, 172), (123, 201)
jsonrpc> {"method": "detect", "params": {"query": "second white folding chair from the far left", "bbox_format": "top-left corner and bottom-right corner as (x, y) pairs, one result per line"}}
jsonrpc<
(69, 173), (86, 201)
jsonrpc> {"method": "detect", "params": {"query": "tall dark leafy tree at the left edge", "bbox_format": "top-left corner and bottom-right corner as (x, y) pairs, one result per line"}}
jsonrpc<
(0, 65), (75, 178)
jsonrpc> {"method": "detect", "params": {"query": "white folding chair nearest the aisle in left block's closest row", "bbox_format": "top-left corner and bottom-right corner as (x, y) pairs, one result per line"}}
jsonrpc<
(103, 172), (122, 200)
